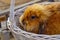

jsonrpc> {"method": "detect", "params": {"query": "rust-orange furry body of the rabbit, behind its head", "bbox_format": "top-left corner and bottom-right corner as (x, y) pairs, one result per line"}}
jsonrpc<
(44, 3), (60, 35)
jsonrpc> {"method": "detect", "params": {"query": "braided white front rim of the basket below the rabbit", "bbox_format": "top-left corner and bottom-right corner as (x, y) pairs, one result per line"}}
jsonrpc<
(8, 21), (60, 39)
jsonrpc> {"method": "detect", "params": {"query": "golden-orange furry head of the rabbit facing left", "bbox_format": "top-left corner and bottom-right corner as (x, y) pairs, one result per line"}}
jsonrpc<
(19, 4), (48, 33)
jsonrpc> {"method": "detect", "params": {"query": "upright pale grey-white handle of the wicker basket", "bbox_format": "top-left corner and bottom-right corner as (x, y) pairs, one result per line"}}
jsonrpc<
(9, 0), (16, 27)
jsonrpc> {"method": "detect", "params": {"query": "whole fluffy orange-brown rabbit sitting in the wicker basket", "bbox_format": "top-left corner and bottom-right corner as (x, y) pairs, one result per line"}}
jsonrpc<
(19, 2), (60, 35)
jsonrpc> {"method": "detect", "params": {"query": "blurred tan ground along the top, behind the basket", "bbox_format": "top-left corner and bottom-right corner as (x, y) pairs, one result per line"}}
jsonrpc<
(0, 0), (60, 10)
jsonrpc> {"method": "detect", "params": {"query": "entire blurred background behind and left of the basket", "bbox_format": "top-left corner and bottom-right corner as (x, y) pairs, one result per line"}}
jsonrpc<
(0, 0), (60, 40)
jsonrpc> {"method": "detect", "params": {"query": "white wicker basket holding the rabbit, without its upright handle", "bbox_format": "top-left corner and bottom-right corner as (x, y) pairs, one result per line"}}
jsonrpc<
(8, 3), (60, 40)
